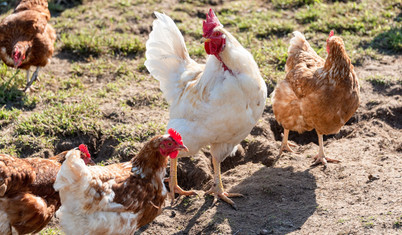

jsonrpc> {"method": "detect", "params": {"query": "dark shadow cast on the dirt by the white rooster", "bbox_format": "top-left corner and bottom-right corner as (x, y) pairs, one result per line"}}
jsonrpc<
(164, 167), (318, 235)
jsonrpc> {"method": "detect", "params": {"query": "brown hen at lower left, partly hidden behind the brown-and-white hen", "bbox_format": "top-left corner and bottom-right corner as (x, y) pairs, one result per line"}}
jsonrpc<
(0, 145), (93, 234)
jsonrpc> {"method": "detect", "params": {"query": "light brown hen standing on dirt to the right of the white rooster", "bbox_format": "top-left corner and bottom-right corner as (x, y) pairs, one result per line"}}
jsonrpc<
(272, 31), (360, 166)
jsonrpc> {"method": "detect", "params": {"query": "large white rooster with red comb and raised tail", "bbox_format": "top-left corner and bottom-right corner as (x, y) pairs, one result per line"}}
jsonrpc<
(145, 9), (267, 208)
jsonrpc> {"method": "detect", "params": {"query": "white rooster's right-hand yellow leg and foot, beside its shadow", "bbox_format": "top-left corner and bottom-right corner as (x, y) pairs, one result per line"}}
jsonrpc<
(207, 156), (243, 210)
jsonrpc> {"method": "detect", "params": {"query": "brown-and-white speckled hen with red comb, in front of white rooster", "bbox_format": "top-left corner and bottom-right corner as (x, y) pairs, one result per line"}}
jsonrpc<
(54, 129), (188, 235)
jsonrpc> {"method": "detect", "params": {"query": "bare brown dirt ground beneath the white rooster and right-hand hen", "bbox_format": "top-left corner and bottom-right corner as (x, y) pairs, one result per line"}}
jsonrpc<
(133, 57), (402, 235)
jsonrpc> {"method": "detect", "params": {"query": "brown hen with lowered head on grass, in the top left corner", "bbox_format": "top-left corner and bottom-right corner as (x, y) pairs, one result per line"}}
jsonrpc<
(0, 0), (56, 91)
